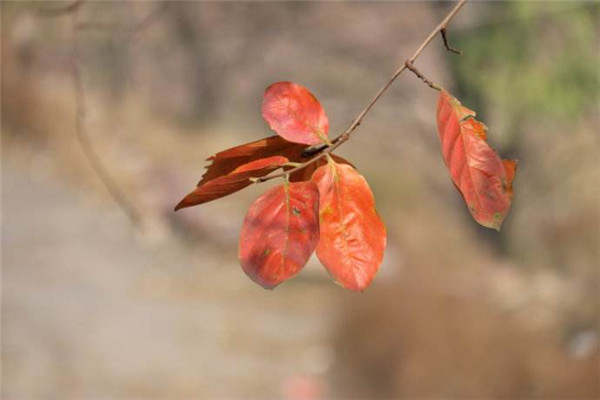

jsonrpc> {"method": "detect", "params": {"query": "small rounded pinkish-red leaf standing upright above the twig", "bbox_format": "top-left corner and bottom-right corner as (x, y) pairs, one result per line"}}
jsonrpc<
(262, 82), (329, 145)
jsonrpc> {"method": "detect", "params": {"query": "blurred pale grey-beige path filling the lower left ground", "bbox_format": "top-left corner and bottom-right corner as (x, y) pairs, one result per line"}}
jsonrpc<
(2, 165), (341, 399)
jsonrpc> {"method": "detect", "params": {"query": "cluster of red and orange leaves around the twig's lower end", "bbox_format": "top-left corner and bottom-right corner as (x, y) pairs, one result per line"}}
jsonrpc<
(176, 82), (386, 291)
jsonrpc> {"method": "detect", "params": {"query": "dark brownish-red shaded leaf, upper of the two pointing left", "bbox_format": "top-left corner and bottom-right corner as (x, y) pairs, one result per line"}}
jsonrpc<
(198, 135), (306, 185)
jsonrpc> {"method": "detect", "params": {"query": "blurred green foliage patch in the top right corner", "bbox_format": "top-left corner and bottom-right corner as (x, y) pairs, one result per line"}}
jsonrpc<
(449, 2), (600, 147)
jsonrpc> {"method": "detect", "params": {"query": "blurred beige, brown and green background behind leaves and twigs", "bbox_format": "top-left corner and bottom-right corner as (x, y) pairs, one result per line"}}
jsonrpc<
(1, 1), (600, 399)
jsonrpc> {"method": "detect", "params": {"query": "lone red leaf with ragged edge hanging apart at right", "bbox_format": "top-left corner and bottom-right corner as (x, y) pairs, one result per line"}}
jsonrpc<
(437, 90), (516, 230)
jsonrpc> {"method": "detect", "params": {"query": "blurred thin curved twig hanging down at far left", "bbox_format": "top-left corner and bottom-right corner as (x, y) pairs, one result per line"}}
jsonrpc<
(71, 3), (142, 230)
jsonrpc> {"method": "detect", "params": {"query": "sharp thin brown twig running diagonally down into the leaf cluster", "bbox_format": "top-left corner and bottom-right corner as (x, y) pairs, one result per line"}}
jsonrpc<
(256, 0), (467, 183)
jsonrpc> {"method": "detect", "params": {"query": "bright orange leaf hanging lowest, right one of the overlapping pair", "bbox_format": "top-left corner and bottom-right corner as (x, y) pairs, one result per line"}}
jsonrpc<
(312, 161), (386, 291)
